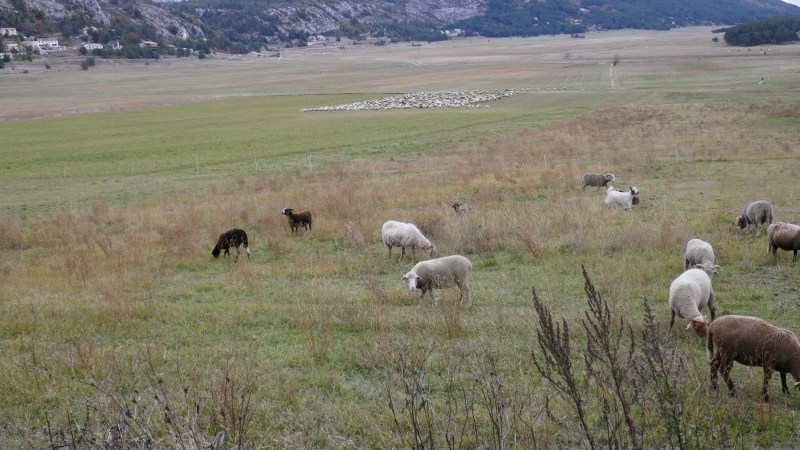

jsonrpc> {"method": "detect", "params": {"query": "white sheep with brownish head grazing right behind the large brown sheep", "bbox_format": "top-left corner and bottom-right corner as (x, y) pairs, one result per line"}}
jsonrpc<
(669, 264), (719, 337)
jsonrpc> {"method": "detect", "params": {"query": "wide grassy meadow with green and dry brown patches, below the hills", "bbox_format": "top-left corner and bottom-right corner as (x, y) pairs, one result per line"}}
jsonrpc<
(0, 28), (800, 448)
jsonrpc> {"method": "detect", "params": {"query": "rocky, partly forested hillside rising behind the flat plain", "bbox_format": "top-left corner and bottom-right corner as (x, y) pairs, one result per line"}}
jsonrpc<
(0, 0), (800, 53)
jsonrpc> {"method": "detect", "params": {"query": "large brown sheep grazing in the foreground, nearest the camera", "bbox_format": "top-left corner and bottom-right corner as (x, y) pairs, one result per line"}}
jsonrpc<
(706, 315), (800, 402)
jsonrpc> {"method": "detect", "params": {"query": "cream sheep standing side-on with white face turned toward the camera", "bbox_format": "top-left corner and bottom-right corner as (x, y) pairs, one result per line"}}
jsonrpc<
(403, 255), (472, 306)
